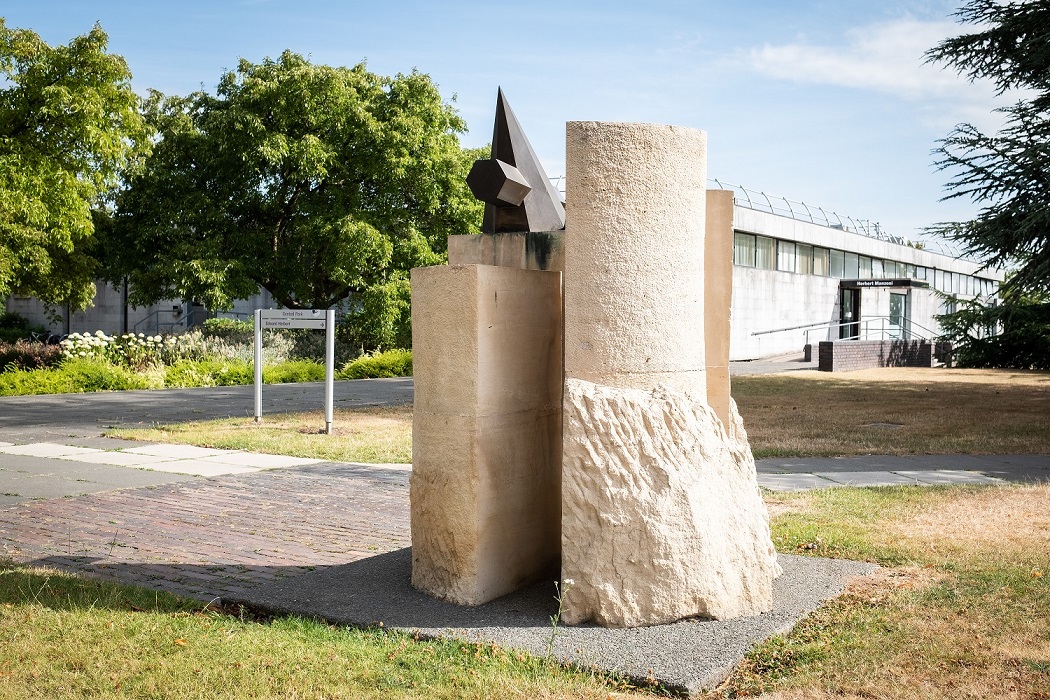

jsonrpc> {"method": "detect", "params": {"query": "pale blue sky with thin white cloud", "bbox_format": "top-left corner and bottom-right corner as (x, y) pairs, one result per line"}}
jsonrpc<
(3, 0), (1002, 245)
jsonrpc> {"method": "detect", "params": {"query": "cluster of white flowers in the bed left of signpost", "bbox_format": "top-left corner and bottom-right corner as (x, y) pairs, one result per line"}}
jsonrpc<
(61, 331), (207, 369)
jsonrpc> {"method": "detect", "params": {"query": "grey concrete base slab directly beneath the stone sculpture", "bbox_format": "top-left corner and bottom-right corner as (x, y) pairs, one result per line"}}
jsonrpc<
(238, 548), (876, 693)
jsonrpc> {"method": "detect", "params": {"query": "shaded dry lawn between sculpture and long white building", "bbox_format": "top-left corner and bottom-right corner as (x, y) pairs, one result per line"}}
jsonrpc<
(733, 367), (1050, 458)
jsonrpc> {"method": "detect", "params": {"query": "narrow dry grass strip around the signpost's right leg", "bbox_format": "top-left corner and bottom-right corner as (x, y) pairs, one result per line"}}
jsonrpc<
(106, 406), (412, 464)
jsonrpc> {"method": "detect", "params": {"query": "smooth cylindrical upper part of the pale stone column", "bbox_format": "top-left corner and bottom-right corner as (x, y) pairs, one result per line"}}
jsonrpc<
(565, 122), (707, 399)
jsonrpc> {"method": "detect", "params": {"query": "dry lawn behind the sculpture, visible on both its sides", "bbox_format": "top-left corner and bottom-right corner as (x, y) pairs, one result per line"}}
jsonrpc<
(108, 368), (1050, 463)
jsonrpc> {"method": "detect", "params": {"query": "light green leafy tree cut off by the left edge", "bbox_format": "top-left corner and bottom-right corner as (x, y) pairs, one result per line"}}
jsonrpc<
(0, 18), (148, 310)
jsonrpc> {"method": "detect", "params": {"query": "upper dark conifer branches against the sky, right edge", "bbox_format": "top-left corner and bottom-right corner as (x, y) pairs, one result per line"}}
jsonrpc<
(927, 0), (1050, 293)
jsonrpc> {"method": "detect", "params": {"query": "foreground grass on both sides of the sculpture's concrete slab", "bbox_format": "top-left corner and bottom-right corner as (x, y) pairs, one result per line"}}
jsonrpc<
(0, 486), (1050, 700)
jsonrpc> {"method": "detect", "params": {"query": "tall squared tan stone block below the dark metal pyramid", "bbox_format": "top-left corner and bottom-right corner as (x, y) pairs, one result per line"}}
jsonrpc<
(410, 264), (562, 604)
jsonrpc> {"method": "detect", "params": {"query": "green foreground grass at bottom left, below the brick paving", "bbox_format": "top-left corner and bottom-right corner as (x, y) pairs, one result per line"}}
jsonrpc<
(0, 565), (638, 699)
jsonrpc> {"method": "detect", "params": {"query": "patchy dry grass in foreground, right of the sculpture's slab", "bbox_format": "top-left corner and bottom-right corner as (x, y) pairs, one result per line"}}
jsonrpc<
(710, 486), (1050, 700)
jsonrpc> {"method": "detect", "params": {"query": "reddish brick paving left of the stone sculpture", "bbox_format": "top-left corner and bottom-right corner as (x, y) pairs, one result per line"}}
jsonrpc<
(0, 463), (411, 600)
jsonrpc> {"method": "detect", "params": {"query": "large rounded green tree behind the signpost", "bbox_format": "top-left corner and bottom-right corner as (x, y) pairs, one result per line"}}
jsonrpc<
(108, 51), (482, 327)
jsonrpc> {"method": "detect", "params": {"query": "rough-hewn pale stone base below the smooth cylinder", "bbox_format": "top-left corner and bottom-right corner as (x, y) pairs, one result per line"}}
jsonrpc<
(562, 379), (780, 627)
